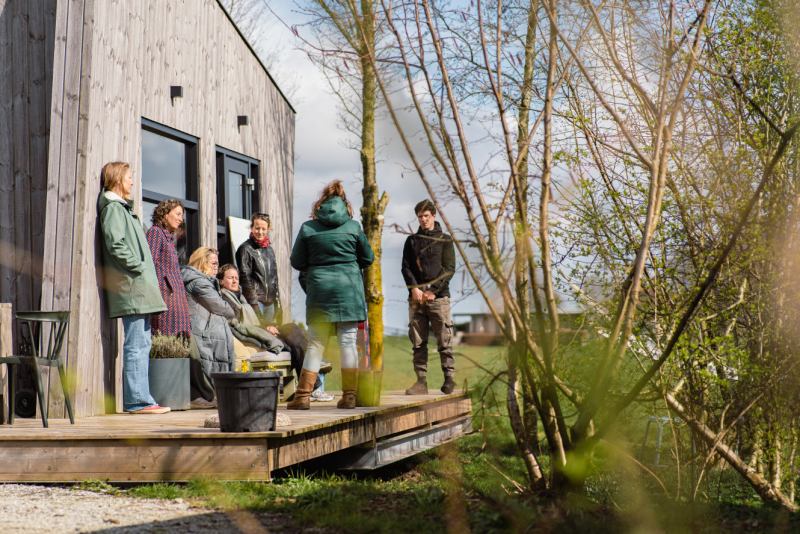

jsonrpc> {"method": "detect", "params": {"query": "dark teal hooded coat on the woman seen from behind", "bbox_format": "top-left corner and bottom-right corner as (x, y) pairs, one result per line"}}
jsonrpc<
(291, 197), (375, 323)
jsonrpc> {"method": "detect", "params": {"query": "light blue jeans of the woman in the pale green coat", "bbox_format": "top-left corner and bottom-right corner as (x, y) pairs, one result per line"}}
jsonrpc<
(121, 315), (156, 412)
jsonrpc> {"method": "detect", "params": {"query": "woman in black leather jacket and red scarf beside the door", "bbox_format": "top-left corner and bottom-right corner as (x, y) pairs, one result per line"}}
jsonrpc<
(236, 213), (283, 327)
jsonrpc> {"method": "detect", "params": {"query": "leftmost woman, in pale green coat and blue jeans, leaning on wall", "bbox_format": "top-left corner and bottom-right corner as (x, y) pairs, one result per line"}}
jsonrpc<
(97, 161), (169, 414)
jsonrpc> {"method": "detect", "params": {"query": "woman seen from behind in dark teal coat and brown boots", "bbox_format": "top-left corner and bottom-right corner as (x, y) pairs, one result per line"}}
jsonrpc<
(287, 180), (375, 410)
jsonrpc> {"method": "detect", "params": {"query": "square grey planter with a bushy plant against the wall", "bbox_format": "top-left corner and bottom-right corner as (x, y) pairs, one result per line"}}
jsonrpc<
(150, 334), (191, 410)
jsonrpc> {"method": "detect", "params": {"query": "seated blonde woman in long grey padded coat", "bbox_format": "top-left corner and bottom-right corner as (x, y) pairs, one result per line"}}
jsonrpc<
(181, 247), (236, 408)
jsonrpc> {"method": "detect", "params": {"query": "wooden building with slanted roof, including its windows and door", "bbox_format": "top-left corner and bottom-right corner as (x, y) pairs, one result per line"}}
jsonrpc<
(0, 0), (295, 417)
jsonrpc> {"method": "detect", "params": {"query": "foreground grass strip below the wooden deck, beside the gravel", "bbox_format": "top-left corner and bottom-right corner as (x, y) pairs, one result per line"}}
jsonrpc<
(120, 428), (800, 534)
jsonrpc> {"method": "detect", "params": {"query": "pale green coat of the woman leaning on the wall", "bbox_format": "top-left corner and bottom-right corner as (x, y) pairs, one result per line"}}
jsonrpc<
(97, 189), (167, 319)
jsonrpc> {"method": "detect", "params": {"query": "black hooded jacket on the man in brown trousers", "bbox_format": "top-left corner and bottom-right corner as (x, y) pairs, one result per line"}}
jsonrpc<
(402, 222), (456, 299)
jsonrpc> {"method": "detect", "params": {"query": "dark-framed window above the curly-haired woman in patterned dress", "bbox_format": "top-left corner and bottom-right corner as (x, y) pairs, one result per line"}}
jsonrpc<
(142, 118), (200, 265)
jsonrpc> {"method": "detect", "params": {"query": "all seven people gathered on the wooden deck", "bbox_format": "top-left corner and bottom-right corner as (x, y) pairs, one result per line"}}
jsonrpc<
(97, 162), (455, 414)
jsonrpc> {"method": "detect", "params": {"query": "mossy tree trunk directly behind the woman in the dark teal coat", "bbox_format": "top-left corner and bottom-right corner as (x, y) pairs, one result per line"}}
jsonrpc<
(359, 0), (389, 371)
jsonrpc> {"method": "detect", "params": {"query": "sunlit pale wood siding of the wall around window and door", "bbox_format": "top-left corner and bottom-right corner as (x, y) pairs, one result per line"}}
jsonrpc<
(43, 0), (294, 417)
